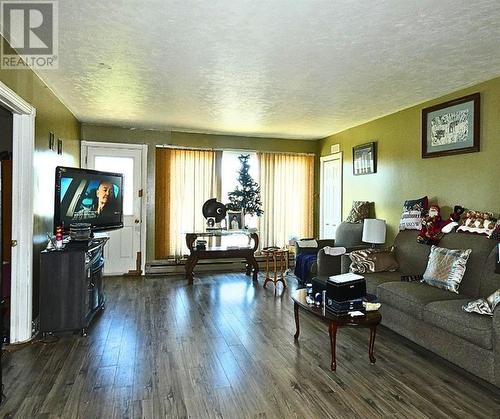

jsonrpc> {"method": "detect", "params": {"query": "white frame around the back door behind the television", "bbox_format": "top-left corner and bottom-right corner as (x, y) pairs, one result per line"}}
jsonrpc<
(81, 140), (148, 275)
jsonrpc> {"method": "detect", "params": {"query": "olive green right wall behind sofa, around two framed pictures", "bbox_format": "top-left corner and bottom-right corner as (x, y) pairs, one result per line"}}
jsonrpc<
(319, 78), (500, 243)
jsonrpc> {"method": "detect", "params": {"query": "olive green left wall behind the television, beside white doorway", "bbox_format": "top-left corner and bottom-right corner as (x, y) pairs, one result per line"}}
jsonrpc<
(0, 57), (80, 317)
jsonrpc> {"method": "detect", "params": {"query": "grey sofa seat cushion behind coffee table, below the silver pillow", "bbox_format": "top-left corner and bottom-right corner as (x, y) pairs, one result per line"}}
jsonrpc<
(377, 281), (464, 320)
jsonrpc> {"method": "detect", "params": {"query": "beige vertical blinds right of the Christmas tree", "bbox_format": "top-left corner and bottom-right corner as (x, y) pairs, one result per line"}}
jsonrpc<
(257, 153), (314, 248)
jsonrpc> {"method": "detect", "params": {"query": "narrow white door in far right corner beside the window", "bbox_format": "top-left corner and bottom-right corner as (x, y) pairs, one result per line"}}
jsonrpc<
(320, 153), (342, 239)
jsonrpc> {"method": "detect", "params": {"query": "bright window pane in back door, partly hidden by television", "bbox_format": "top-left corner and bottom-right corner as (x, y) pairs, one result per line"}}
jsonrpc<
(94, 156), (134, 215)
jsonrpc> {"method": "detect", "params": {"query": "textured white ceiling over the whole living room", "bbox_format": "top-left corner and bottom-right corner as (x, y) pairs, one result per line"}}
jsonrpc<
(39, 0), (500, 139)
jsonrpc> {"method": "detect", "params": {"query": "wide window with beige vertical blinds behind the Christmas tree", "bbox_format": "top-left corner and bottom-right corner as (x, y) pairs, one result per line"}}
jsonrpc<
(155, 149), (314, 259)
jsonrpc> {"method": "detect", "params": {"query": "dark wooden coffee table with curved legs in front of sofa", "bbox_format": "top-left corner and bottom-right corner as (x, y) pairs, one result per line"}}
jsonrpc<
(292, 289), (382, 371)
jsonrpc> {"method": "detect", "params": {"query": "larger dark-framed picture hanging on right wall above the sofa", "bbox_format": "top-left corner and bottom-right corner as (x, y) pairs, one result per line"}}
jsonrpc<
(422, 93), (481, 159)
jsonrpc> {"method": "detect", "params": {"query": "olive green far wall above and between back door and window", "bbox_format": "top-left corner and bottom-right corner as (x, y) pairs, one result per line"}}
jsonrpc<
(81, 124), (317, 261)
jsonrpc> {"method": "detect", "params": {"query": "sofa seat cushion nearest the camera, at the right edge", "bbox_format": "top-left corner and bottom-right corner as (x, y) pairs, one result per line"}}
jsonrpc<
(424, 298), (493, 349)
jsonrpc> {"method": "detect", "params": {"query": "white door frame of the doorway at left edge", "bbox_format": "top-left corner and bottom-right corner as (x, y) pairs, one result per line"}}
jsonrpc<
(0, 82), (36, 343)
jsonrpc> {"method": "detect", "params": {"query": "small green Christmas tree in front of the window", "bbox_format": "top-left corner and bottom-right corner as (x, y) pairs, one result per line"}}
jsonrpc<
(226, 154), (264, 217)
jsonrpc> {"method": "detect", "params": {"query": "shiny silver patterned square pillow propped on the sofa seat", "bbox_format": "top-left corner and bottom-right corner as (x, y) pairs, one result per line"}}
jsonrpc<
(422, 246), (472, 294)
